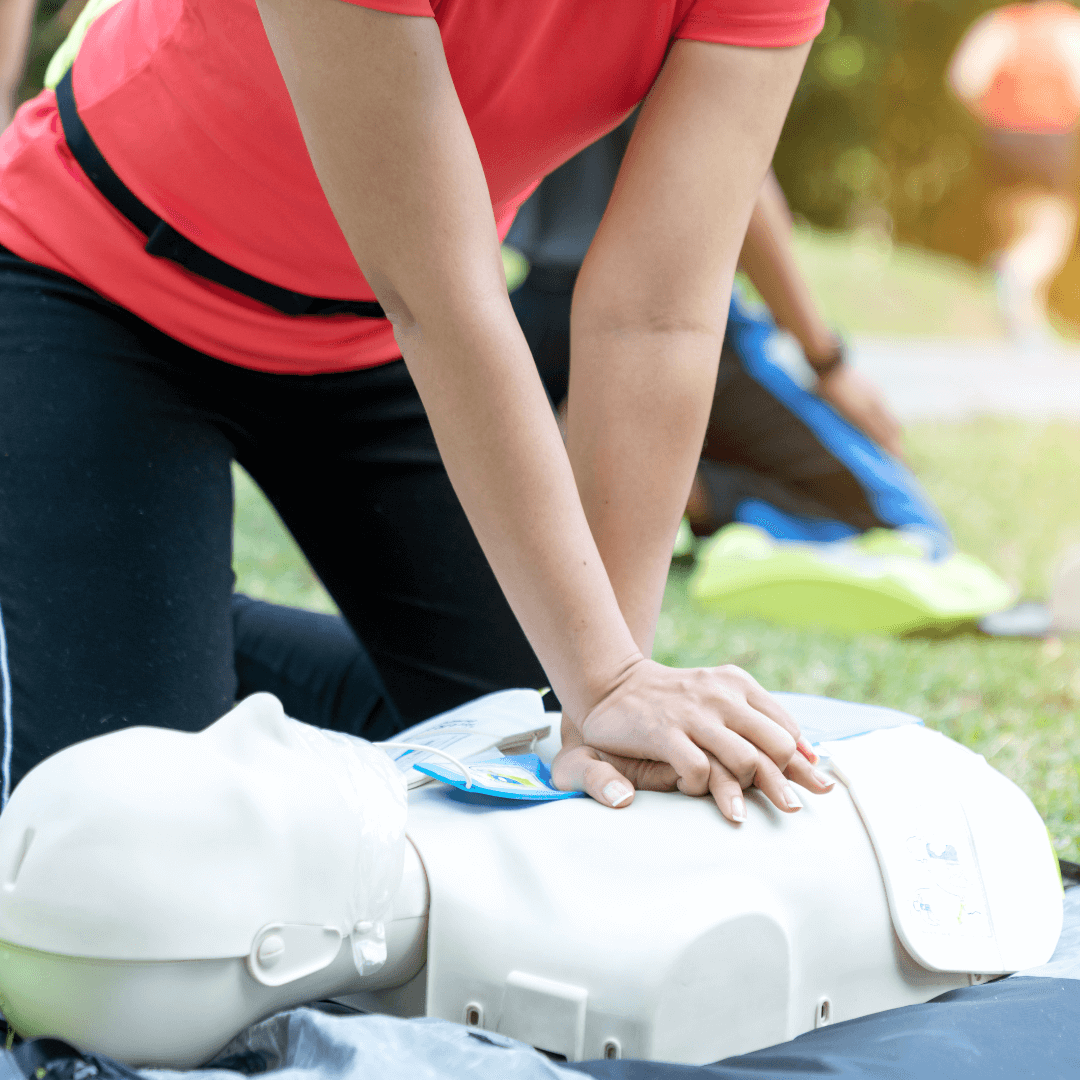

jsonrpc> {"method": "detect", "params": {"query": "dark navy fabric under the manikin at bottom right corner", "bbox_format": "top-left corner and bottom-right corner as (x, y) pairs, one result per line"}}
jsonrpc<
(565, 977), (1080, 1080)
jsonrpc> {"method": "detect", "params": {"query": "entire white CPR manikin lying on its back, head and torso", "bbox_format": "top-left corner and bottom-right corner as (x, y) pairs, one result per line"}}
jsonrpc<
(0, 691), (1062, 1065)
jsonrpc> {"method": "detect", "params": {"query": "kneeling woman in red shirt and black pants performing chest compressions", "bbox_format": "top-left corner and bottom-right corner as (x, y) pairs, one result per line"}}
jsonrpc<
(0, 0), (828, 821)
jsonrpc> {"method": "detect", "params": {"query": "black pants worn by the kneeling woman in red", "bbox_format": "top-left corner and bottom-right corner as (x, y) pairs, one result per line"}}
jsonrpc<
(0, 248), (545, 789)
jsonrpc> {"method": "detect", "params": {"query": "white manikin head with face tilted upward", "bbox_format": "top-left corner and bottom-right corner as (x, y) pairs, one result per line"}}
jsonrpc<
(0, 694), (406, 1065)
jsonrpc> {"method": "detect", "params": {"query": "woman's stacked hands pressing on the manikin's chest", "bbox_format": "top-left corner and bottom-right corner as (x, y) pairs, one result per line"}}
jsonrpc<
(552, 659), (833, 822)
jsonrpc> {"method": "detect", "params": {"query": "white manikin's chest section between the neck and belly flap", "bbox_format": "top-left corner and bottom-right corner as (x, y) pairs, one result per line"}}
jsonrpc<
(408, 760), (968, 1064)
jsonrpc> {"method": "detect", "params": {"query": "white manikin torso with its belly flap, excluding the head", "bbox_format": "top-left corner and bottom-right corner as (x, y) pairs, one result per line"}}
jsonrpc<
(386, 697), (1061, 1064)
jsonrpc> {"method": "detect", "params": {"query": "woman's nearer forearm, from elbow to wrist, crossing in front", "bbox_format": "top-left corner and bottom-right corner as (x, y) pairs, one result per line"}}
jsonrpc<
(400, 303), (639, 717)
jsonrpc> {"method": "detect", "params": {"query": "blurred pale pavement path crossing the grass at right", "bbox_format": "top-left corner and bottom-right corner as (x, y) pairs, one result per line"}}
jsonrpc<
(842, 338), (1080, 423)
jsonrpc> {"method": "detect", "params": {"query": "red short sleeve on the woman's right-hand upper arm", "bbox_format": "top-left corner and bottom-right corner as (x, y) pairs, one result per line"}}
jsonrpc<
(675, 0), (828, 49)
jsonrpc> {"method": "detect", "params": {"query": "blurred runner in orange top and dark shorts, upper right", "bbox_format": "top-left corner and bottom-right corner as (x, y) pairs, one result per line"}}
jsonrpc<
(948, 0), (1080, 345)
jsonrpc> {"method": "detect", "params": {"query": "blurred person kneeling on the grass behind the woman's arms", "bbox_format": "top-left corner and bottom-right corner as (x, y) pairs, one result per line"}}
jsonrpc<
(507, 120), (950, 552)
